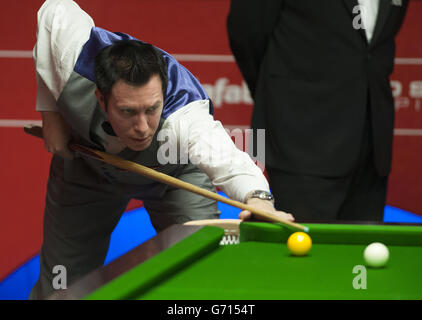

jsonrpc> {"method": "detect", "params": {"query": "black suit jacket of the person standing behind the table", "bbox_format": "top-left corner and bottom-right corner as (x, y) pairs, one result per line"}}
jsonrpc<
(227, 0), (408, 177)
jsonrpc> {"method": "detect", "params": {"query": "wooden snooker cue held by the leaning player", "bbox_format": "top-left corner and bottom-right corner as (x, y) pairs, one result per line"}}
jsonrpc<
(24, 125), (309, 232)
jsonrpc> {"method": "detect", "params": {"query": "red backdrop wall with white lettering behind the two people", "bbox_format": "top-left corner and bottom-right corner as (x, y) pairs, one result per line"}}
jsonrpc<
(0, 0), (422, 280)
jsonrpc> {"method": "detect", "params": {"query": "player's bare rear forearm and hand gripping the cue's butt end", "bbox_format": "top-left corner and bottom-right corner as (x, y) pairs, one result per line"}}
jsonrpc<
(41, 111), (74, 159)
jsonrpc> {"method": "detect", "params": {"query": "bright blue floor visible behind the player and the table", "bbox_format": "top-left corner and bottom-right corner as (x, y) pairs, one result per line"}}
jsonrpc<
(0, 193), (422, 300)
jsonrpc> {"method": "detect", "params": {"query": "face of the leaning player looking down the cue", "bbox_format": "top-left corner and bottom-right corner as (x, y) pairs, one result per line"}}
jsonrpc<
(95, 75), (164, 151)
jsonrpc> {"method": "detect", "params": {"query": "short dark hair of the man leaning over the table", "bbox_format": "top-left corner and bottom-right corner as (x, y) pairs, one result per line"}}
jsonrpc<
(95, 40), (168, 100)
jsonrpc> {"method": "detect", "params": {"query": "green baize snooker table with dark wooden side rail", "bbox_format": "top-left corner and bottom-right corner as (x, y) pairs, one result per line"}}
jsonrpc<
(48, 222), (422, 300)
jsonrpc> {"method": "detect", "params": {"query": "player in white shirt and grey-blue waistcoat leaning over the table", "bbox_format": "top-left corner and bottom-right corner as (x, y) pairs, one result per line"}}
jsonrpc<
(30, 0), (293, 299)
